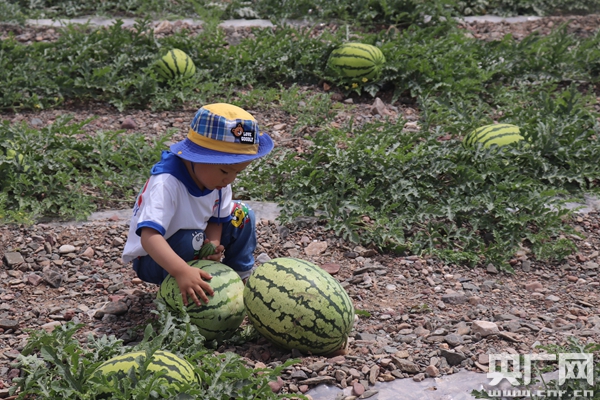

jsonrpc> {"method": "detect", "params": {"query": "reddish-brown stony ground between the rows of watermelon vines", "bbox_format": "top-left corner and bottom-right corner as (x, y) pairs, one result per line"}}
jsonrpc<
(0, 16), (600, 398)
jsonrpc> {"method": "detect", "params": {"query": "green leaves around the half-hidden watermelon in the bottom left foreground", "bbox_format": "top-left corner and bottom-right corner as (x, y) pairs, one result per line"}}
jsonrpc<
(10, 302), (304, 400)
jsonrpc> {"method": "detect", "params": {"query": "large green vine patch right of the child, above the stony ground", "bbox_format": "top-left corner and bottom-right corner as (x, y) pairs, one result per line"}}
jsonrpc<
(241, 82), (600, 270)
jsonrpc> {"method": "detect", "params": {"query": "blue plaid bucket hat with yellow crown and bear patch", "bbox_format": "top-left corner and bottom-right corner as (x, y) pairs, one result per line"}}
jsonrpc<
(171, 103), (273, 164)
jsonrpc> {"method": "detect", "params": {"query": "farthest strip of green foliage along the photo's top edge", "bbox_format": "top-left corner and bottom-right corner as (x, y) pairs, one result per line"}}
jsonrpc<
(8, 0), (600, 27)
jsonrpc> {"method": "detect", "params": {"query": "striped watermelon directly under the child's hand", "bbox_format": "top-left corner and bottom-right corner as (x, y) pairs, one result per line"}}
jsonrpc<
(157, 260), (246, 341)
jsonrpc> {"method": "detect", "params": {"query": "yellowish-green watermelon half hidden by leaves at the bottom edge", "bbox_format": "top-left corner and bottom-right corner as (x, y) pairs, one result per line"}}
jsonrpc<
(94, 350), (199, 385)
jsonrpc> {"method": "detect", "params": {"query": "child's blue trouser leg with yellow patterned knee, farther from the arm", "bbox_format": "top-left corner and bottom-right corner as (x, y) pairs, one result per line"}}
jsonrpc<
(221, 201), (256, 279)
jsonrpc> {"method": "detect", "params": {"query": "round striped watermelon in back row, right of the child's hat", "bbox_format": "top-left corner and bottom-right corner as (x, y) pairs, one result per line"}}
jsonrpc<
(327, 43), (385, 82)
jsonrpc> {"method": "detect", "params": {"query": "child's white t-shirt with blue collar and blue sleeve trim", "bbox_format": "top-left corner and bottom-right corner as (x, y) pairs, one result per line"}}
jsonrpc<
(123, 151), (233, 263)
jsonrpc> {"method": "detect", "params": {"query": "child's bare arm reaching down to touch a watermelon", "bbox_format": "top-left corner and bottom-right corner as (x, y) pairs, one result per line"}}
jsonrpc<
(141, 228), (216, 306)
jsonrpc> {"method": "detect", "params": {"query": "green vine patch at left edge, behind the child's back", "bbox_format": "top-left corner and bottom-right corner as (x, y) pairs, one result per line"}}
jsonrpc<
(0, 116), (167, 221)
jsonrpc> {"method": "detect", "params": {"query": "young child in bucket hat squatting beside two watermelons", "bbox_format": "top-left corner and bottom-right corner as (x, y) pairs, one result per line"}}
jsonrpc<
(123, 103), (273, 305)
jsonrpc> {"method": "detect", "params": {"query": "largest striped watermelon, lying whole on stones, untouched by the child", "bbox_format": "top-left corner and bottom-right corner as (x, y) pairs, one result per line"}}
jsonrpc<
(244, 257), (354, 354)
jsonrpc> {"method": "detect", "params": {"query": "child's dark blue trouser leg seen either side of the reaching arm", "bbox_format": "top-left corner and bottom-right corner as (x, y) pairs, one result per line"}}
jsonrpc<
(133, 229), (204, 285)
